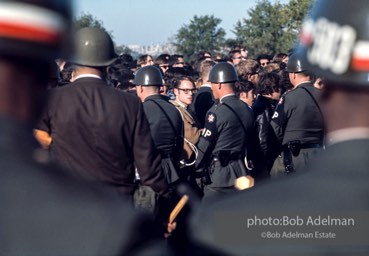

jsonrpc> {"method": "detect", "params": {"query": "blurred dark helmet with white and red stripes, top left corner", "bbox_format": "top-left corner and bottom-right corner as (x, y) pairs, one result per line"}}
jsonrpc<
(0, 0), (72, 61)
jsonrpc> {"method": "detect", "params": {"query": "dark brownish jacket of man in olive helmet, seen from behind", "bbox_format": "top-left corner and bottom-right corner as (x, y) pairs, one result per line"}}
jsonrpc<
(36, 77), (167, 195)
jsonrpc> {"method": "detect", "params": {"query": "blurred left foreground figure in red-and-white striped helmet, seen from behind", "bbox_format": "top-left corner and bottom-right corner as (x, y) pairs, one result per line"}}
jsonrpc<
(0, 0), (161, 255)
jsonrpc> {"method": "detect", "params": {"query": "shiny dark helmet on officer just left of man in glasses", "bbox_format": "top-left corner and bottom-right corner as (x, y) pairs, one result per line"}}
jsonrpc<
(133, 66), (163, 86)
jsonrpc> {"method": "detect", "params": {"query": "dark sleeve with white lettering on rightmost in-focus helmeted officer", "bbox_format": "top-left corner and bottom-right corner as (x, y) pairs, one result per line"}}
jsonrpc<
(270, 96), (290, 143)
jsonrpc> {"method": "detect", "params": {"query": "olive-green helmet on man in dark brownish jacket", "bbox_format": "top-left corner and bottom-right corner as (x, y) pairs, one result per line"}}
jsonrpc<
(72, 28), (118, 67)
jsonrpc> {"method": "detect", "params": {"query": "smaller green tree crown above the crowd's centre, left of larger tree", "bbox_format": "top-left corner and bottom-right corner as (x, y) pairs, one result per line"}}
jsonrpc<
(174, 15), (225, 61)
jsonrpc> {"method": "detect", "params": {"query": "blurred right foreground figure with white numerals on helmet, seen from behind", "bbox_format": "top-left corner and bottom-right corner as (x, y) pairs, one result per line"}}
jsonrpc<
(190, 0), (369, 255)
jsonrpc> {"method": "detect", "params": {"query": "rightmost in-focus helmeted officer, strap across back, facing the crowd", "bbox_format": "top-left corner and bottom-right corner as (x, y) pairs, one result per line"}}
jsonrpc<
(271, 52), (324, 175)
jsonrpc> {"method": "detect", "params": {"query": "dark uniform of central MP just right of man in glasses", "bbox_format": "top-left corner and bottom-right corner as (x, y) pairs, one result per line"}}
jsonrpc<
(195, 94), (254, 188)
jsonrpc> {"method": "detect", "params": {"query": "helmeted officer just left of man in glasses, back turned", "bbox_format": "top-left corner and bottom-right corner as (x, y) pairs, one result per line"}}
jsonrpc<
(134, 66), (184, 185)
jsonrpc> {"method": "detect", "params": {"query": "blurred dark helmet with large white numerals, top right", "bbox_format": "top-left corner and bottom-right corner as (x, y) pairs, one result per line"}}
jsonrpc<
(300, 0), (369, 86)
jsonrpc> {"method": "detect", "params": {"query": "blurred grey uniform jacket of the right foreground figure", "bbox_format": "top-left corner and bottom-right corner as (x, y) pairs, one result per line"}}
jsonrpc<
(192, 138), (369, 256)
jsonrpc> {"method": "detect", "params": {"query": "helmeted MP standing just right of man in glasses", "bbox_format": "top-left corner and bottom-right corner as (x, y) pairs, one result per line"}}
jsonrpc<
(195, 62), (253, 197)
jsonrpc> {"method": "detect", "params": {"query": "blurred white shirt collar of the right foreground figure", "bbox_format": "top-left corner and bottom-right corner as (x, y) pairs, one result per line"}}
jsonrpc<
(326, 127), (369, 146)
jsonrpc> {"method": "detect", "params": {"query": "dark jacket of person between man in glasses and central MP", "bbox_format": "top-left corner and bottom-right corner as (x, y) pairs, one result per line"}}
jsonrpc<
(189, 86), (215, 128)
